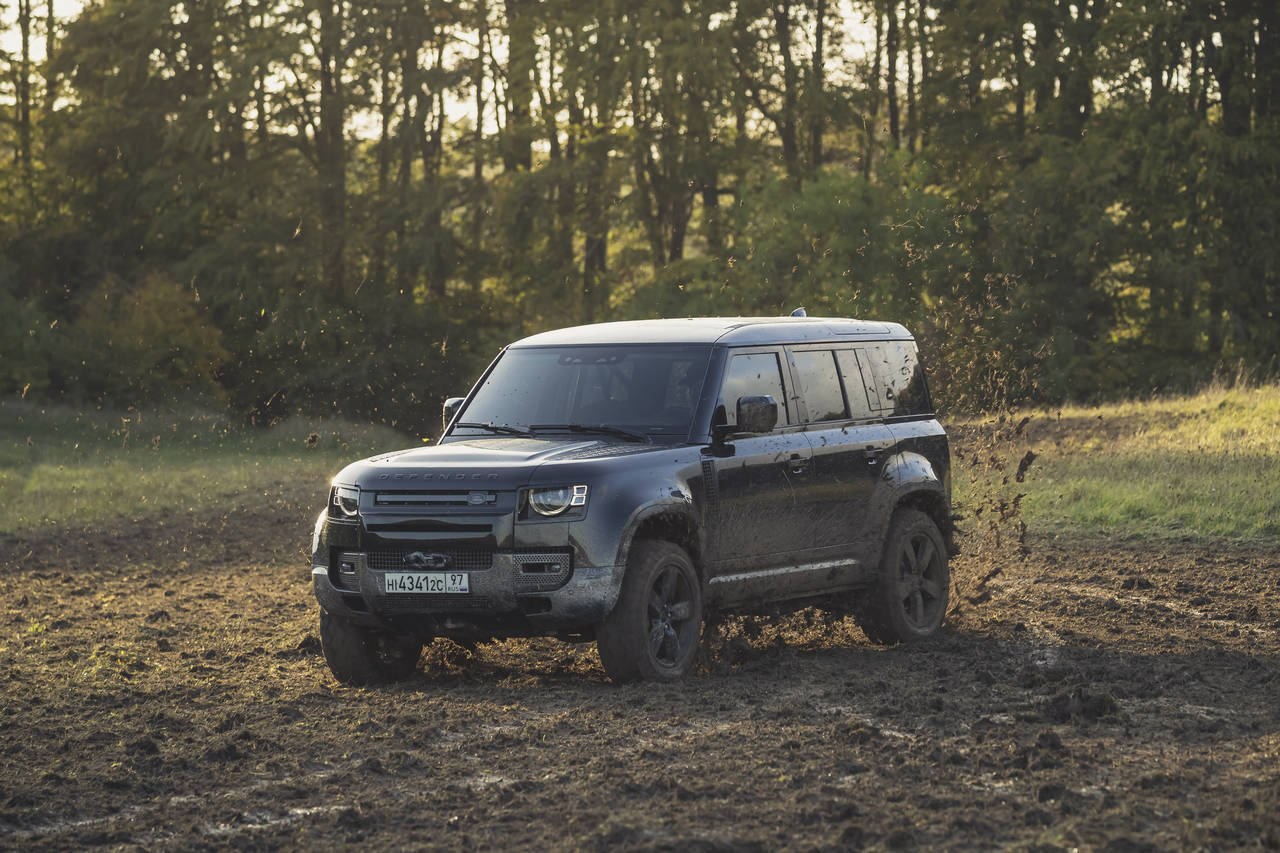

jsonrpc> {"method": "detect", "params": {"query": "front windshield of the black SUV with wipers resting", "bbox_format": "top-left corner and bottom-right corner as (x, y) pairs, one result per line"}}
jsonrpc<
(454, 346), (710, 435)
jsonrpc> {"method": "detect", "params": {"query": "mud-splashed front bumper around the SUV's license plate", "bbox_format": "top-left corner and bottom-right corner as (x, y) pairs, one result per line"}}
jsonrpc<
(311, 551), (622, 635)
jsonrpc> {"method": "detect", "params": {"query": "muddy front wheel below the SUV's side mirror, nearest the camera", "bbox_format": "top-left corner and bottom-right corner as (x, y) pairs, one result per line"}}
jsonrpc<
(595, 539), (703, 684)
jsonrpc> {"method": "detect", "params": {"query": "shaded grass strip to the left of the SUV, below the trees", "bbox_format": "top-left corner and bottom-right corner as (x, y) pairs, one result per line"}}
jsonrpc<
(0, 401), (416, 533)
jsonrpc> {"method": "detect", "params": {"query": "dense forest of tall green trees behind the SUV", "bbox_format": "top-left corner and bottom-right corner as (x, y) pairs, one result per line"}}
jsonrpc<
(0, 0), (1280, 429)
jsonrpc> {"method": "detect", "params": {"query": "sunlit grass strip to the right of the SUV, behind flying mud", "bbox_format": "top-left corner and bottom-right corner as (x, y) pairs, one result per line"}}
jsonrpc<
(955, 386), (1280, 543)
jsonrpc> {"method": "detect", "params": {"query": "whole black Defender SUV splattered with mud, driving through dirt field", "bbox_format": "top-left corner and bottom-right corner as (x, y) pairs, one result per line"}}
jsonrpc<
(311, 318), (952, 684)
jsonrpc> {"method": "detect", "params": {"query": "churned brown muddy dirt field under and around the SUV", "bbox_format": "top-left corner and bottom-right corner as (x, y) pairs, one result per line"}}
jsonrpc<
(0, 473), (1280, 850)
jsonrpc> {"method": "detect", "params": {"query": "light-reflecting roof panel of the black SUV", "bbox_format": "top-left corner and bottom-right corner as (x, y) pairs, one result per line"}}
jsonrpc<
(511, 316), (911, 347)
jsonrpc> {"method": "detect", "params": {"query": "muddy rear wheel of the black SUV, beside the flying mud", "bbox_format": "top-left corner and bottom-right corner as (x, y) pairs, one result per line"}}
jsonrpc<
(854, 508), (951, 646)
